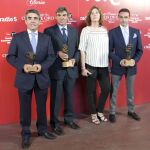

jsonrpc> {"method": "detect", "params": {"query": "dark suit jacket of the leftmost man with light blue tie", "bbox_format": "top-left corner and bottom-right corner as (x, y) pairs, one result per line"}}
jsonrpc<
(7, 32), (55, 90)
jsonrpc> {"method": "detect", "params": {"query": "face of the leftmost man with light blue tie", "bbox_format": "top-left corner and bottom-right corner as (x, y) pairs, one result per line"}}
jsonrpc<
(25, 13), (40, 32)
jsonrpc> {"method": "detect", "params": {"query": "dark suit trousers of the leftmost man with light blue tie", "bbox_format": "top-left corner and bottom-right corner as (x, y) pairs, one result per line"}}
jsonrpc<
(18, 80), (48, 137)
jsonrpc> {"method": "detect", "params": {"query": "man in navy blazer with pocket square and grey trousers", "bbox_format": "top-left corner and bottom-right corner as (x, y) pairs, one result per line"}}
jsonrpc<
(109, 8), (143, 122)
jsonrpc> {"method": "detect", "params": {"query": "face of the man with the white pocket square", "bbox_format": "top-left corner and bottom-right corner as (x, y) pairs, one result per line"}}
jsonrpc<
(118, 12), (130, 27)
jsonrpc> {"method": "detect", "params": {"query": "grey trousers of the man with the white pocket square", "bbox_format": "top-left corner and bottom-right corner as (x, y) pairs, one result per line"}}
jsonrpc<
(110, 74), (135, 114)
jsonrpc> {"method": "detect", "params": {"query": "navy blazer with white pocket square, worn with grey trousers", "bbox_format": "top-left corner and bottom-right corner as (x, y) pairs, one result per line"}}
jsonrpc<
(109, 26), (143, 75)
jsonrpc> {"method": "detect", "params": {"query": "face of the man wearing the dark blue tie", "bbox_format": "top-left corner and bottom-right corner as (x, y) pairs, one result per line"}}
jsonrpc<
(56, 11), (68, 26)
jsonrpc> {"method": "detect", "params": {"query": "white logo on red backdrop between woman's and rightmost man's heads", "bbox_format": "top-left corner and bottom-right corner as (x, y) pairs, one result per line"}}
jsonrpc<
(103, 12), (118, 23)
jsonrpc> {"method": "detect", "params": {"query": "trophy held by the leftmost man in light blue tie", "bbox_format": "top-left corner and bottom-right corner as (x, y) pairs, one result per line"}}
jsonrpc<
(26, 51), (38, 73)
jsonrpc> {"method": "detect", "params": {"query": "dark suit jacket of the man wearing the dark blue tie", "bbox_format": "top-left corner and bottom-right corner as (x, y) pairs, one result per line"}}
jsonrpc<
(44, 25), (80, 79)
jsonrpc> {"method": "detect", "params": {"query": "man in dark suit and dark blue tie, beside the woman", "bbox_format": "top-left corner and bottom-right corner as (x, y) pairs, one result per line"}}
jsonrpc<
(44, 7), (79, 135)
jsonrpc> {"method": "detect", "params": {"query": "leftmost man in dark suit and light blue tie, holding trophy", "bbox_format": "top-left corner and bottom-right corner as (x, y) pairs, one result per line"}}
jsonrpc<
(7, 9), (55, 148)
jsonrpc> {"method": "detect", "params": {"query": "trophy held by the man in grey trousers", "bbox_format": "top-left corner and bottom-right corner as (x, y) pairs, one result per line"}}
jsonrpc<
(125, 44), (134, 67)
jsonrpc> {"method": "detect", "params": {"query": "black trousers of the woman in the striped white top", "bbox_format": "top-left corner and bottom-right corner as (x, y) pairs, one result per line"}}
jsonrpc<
(86, 65), (110, 114)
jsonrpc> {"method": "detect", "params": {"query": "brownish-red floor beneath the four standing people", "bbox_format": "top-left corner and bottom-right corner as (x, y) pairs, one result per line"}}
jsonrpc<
(0, 103), (150, 150)
